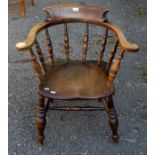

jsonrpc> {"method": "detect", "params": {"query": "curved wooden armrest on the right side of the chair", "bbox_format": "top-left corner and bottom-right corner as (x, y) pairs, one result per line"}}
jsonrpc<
(104, 22), (139, 52)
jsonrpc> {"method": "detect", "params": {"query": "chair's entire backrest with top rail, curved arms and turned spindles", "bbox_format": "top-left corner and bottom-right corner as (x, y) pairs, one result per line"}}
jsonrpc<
(16, 3), (138, 81)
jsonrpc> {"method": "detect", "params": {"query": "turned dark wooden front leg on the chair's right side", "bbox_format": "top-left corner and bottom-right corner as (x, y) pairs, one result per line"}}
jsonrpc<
(102, 96), (119, 143)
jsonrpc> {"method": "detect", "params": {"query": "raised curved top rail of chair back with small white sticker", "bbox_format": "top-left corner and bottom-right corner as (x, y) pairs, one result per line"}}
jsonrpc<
(43, 3), (109, 21)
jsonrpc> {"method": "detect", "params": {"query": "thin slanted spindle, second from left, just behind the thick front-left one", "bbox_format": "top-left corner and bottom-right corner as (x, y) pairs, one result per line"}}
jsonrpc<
(35, 39), (47, 73)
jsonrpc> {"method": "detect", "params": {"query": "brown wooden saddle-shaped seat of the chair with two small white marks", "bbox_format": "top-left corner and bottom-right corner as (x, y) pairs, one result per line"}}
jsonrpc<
(39, 61), (114, 99)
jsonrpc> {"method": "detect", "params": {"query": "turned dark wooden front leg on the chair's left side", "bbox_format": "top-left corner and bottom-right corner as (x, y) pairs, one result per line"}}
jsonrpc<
(35, 95), (46, 144)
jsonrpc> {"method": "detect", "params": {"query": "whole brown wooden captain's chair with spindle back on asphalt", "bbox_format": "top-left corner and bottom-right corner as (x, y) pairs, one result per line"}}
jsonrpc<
(16, 4), (138, 144)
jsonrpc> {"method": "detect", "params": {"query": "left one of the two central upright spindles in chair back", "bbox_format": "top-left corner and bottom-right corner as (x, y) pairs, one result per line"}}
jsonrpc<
(64, 24), (69, 62)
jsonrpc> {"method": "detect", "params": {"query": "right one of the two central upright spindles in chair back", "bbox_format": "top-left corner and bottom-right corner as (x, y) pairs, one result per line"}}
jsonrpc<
(82, 23), (89, 62)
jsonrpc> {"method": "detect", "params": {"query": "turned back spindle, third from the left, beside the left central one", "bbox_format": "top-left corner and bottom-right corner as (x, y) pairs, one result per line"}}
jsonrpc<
(45, 28), (54, 64)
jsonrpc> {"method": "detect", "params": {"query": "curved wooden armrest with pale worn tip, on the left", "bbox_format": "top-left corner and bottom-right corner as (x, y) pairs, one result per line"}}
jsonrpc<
(16, 22), (50, 51)
